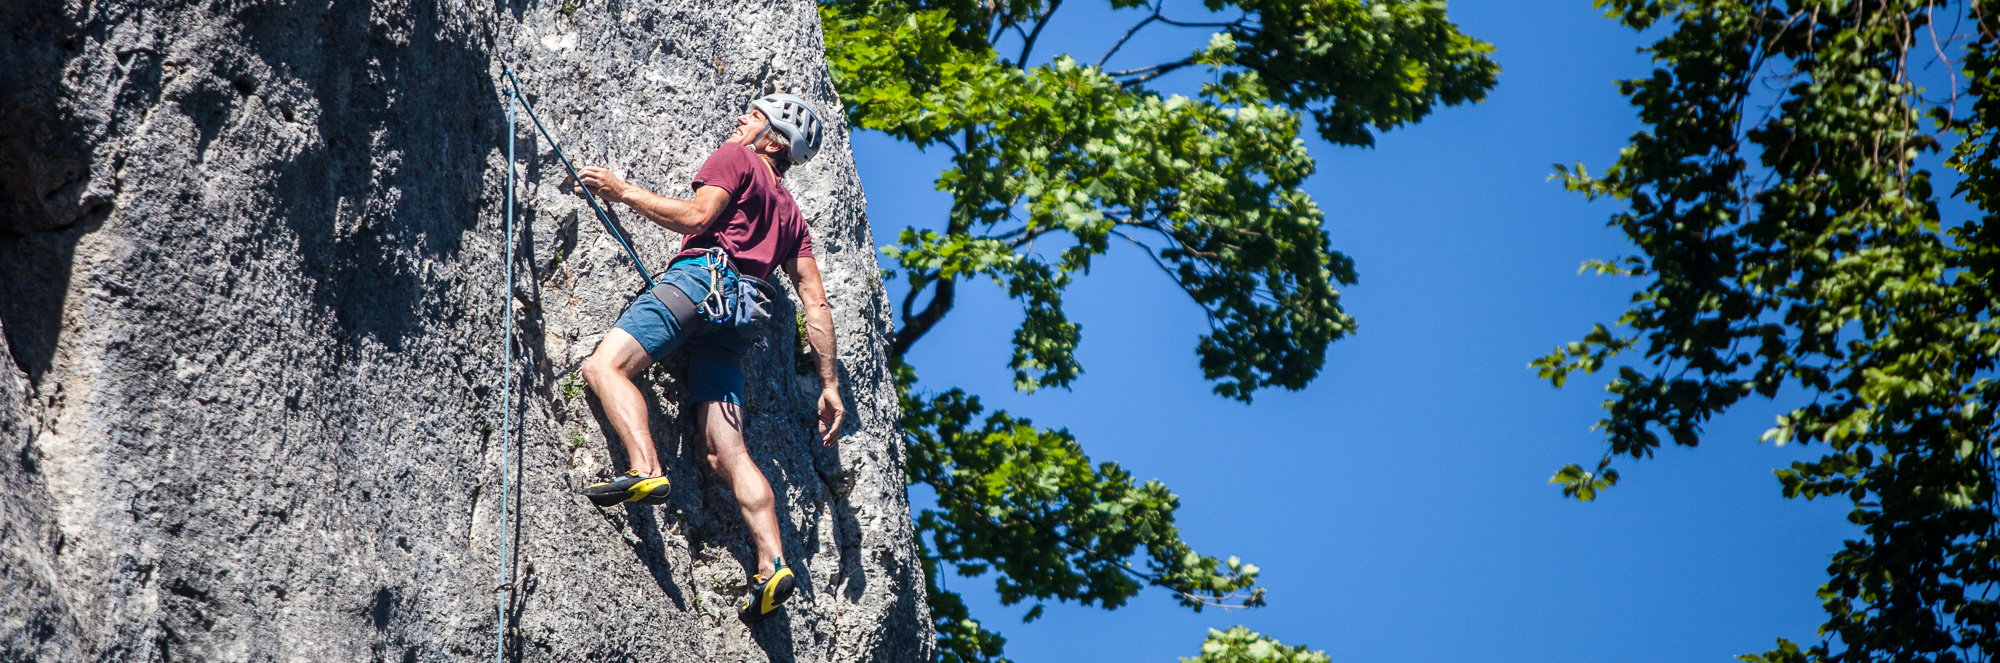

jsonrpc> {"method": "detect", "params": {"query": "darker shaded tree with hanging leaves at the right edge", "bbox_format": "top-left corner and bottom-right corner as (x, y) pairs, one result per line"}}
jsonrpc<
(1534, 0), (2000, 663)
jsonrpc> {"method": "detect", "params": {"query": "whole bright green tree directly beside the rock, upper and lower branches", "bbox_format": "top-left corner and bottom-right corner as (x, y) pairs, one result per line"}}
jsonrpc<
(820, 0), (1496, 661)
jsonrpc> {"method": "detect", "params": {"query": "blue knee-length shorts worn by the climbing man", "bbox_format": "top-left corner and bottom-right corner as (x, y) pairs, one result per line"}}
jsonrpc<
(616, 260), (754, 407)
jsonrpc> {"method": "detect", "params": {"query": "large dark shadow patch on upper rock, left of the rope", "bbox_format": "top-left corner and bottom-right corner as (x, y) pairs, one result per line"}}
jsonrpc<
(236, 2), (504, 359)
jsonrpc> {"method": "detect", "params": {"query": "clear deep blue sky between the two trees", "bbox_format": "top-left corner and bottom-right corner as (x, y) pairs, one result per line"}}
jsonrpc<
(854, 0), (1852, 663)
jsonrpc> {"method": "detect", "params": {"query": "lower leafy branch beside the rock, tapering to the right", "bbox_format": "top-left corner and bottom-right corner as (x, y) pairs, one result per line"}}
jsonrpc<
(898, 365), (1264, 619)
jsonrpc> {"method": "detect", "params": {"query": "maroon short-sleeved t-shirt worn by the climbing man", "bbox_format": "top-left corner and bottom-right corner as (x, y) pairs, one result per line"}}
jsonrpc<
(674, 142), (812, 278)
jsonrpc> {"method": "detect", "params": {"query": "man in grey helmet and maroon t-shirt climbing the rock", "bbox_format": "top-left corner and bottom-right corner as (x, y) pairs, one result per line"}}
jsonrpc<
(576, 94), (846, 623)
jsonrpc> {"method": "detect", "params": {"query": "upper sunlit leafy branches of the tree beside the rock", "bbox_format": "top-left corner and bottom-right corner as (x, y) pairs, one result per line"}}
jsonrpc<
(822, 0), (1496, 399)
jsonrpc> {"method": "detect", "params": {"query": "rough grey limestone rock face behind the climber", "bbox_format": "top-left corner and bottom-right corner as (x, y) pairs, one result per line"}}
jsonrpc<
(0, 0), (932, 661)
